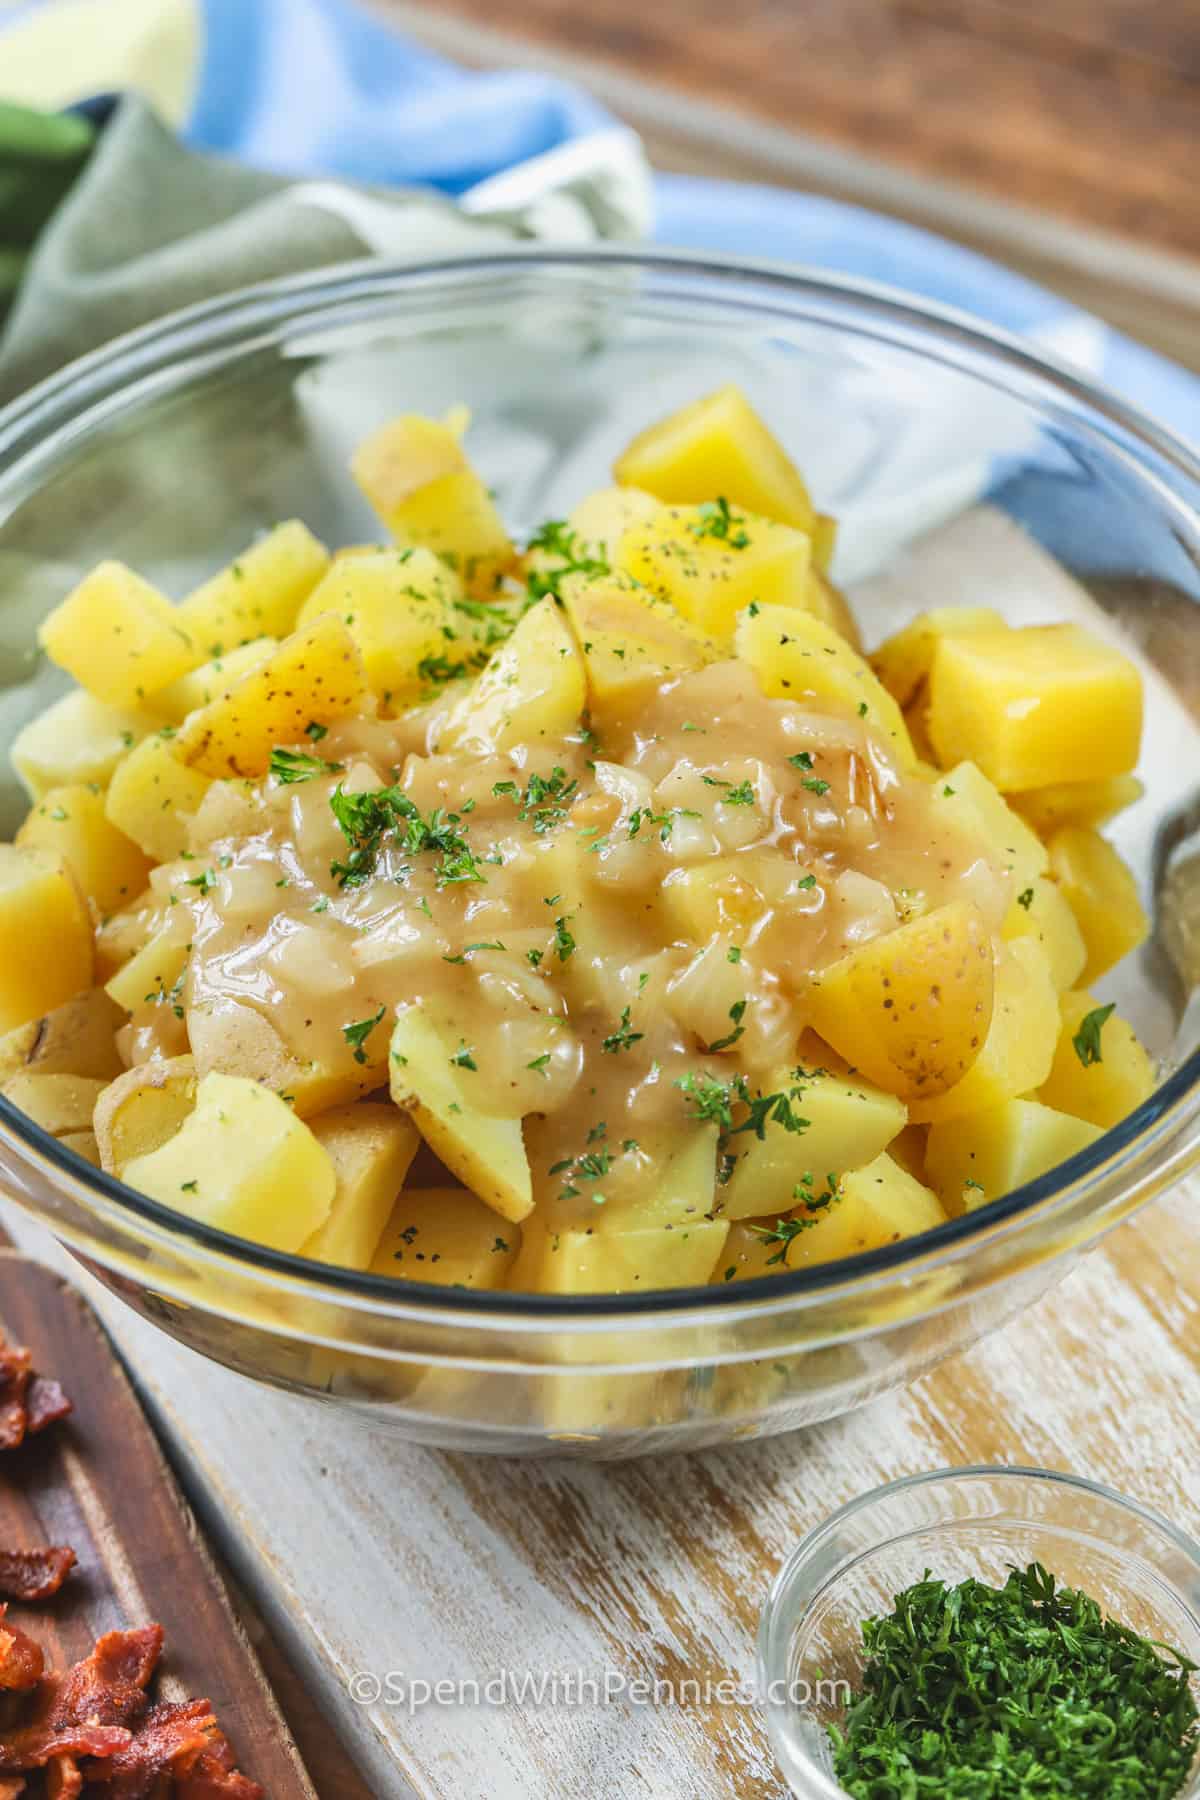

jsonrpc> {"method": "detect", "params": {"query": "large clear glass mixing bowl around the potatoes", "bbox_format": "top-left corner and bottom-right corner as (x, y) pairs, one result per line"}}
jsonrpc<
(0, 250), (1200, 1456)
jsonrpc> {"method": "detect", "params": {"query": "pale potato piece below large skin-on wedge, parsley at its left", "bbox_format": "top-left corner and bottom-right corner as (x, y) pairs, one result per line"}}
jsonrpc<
(716, 1069), (909, 1219)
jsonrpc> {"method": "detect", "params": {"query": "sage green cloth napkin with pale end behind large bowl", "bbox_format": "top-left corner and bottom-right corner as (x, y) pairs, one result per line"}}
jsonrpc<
(0, 95), (648, 403)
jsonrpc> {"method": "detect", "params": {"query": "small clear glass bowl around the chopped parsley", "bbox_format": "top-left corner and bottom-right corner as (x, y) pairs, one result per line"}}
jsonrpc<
(757, 1467), (1200, 1800)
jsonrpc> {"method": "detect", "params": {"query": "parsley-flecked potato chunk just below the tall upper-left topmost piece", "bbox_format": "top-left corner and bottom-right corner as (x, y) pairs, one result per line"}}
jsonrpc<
(300, 549), (470, 707)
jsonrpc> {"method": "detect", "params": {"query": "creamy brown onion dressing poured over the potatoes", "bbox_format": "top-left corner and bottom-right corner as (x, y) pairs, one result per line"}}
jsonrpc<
(126, 662), (1009, 1222)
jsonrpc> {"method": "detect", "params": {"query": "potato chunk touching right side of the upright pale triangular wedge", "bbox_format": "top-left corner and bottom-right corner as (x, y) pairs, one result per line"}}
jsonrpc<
(561, 576), (720, 720)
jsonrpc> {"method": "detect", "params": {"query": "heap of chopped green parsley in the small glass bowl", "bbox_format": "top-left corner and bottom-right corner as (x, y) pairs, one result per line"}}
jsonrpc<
(828, 1562), (1200, 1800)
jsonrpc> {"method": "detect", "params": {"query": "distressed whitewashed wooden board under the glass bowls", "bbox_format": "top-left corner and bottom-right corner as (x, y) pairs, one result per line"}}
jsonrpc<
(5, 1183), (1200, 1800)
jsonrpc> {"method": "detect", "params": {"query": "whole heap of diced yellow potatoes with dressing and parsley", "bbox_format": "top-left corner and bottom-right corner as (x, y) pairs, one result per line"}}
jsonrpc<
(0, 387), (1155, 1296)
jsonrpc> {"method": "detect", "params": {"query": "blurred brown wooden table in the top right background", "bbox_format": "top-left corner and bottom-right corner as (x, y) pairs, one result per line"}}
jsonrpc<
(379, 0), (1200, 369)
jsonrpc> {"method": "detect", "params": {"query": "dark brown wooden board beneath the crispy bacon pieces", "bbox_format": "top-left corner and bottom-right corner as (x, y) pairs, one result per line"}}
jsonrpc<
(0, 1251), (318, 1800)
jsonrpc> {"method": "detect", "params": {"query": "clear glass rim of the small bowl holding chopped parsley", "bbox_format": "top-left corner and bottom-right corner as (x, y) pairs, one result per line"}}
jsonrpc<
(756, 1463), (1200, 1800)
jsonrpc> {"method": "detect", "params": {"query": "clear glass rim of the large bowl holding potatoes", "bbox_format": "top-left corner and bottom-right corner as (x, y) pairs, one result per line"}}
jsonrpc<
(0, 245), (1200, 1324)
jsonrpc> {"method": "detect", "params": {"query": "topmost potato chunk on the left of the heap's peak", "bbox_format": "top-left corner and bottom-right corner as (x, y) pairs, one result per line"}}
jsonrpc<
(351, 412), (515, 592)
